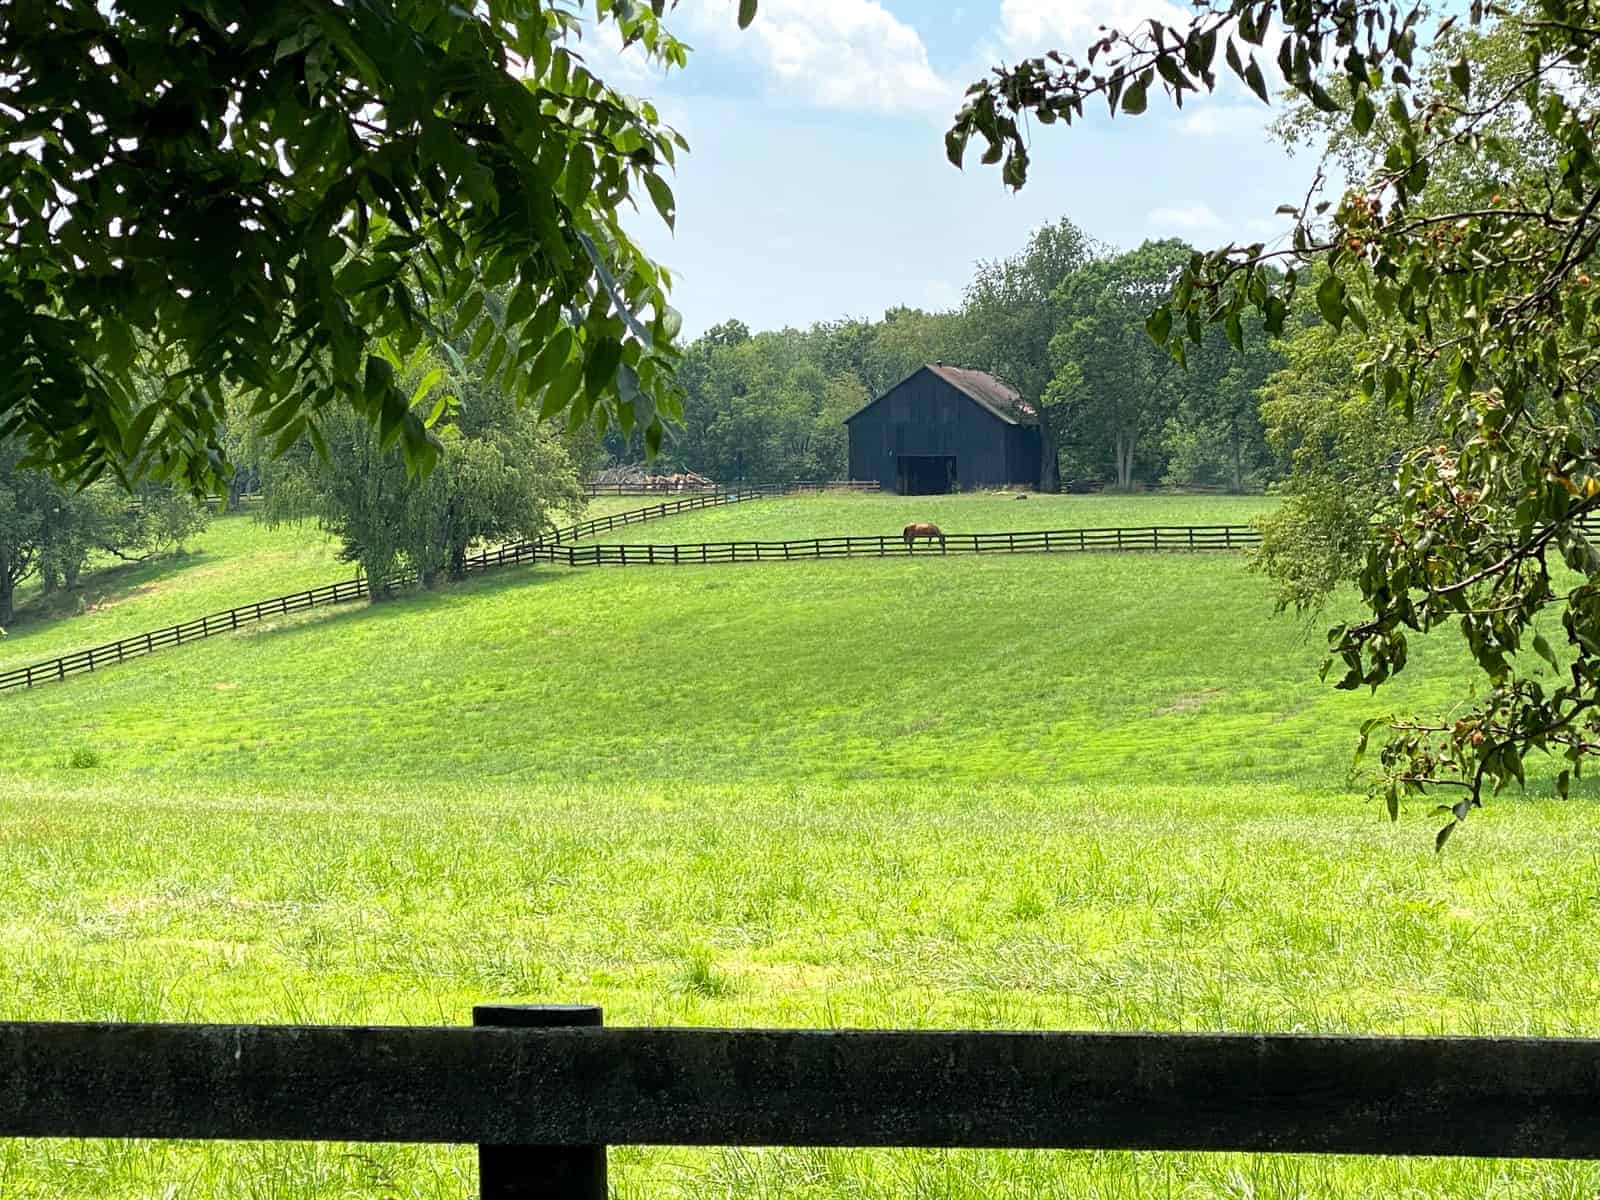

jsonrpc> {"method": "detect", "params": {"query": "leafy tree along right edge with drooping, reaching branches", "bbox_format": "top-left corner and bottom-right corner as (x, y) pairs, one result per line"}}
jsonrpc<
(947, 0), (1600, 845)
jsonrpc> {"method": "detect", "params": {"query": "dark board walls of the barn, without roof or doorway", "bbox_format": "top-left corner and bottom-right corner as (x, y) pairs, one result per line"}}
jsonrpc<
(848, 368), (1038, 491)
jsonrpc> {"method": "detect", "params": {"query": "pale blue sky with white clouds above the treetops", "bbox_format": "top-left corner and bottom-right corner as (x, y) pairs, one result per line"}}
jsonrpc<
(582, 0), (1315, 338)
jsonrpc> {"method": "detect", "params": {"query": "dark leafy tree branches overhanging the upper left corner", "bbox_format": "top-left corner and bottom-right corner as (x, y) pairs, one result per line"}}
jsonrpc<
(0, 0), (685, 488)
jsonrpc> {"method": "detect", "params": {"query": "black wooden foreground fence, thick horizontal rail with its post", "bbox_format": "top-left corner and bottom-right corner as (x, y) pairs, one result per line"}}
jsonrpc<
(0, 1006), (1600, 1200)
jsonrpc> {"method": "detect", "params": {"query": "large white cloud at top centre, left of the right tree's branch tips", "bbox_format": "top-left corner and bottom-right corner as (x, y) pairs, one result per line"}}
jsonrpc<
(677, 0), (965, 120)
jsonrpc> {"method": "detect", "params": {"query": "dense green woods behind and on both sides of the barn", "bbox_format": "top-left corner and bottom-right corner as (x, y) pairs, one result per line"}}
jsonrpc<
(605, 219), (1283, 491)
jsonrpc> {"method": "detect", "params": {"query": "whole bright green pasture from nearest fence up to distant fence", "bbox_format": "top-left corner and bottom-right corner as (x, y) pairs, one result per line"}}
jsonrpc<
(0, 504), (1600, 1200)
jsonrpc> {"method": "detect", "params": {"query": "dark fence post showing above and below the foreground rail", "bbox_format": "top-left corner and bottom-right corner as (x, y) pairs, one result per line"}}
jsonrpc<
(472, 1005), (606, 1200)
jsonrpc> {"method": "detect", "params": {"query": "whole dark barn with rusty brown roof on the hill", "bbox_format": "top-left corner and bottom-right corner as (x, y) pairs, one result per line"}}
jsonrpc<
(845, 363), (1040, 496)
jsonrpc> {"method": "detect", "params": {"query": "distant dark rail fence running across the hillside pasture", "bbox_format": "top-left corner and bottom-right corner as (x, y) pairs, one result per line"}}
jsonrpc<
(0, 524), (1261, 691)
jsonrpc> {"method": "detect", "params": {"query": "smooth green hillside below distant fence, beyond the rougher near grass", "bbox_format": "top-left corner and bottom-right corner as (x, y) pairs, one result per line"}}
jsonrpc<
(0, 555), (1464, 787)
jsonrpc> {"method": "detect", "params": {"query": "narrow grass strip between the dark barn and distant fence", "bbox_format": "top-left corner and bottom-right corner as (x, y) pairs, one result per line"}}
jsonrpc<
(595, 493), (1277, 546)
